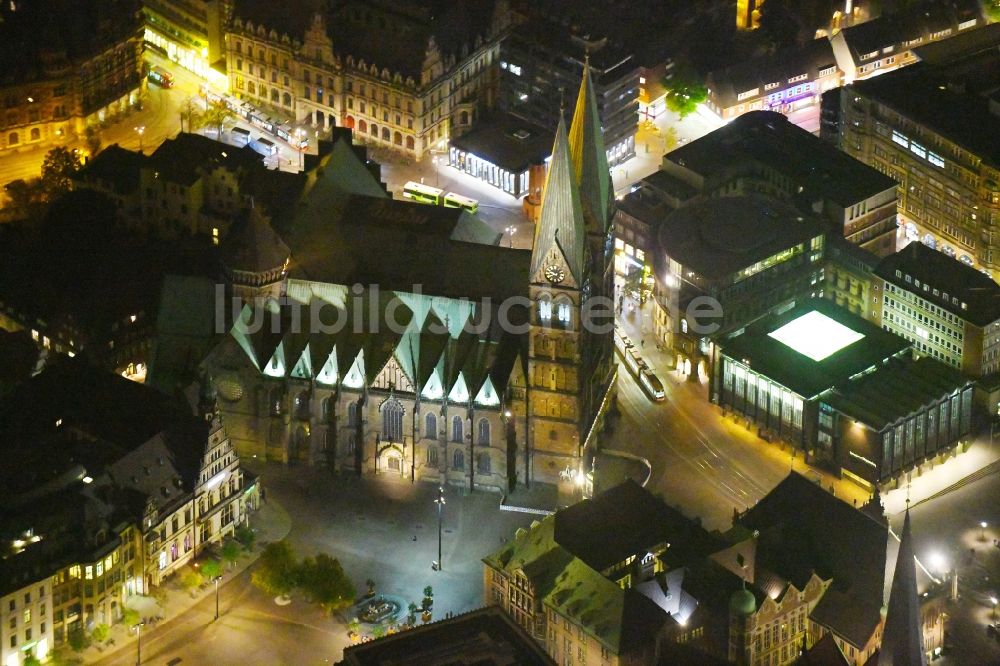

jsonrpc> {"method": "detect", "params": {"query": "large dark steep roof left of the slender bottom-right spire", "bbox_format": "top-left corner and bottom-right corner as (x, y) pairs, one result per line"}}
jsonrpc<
(736, 472), (889, 647)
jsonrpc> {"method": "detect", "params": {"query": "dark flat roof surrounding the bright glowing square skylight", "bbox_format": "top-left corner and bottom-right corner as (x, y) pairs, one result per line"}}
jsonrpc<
(719, 298), (910, 400)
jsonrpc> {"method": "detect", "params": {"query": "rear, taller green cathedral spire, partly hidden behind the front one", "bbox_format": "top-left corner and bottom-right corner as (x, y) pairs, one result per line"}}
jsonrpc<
(569, 58), (614, 235)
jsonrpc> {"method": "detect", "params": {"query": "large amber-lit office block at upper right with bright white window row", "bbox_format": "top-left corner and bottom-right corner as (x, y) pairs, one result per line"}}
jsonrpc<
(824, 33), (1000, 277)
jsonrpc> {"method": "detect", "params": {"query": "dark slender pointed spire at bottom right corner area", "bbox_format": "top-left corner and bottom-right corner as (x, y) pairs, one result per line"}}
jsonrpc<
(878, 508), (927, 666)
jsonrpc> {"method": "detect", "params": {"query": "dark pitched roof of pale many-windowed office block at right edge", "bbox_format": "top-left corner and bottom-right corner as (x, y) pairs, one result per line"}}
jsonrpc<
(875, 239), (1000, 326)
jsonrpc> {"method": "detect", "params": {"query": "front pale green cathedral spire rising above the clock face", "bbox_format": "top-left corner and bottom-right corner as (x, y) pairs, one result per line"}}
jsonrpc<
(531, 118), (586, 285)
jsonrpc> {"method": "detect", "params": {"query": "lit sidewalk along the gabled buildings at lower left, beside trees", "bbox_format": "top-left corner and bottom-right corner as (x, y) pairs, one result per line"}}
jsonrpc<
(78, 500), (292, 663)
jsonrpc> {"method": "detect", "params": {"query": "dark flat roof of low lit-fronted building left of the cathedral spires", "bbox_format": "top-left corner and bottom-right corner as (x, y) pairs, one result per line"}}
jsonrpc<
(451, 114), (555, 173)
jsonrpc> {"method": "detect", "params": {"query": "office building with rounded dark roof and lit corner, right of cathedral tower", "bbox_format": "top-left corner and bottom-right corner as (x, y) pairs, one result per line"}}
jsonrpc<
(653, 195), (827, 380)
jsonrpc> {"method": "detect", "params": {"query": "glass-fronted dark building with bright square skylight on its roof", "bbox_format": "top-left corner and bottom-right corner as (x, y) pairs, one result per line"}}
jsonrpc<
(709, 299), (973, 487)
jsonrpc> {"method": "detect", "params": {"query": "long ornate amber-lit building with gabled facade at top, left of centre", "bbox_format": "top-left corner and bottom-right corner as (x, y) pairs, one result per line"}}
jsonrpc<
(226, 0), (509, 159)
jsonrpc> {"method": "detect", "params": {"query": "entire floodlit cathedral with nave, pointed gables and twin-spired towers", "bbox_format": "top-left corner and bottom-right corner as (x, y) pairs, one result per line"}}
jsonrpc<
(202, 63), (615, 491)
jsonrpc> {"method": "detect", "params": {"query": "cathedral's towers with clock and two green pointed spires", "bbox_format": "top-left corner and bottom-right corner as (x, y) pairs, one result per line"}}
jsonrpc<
(528, 64), (615, 481)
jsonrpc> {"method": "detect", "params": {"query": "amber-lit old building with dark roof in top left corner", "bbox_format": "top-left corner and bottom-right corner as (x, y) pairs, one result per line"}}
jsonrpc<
(0, 0), (142, 154)
